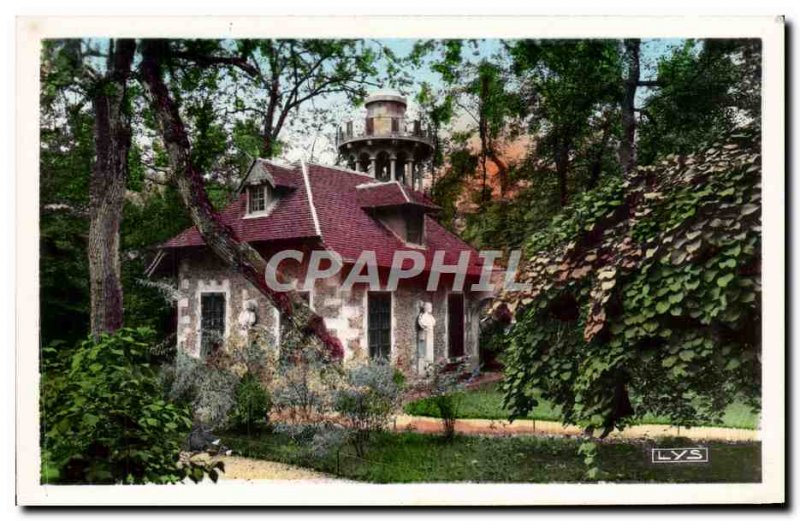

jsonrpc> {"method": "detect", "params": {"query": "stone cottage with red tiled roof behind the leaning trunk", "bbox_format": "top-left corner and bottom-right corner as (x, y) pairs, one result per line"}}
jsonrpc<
(148, 91), (491, 373)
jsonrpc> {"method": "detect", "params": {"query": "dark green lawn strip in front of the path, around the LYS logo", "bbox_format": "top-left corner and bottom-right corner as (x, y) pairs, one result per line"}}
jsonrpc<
(223, 432), (761, 483)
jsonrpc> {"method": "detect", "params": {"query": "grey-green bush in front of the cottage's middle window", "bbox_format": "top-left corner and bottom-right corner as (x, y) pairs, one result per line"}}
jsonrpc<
(333, 363), (400, 456)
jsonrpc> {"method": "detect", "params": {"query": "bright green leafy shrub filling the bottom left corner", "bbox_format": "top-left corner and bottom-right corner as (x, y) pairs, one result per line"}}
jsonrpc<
(41, 329), (191, 483)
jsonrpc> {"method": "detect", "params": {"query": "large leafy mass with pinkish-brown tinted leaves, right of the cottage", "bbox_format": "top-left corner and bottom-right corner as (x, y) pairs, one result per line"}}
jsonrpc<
(498, 128), (761, 434)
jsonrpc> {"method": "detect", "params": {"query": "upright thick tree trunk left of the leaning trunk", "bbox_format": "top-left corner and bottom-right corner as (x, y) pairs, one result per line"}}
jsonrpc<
(88, 40), (136, 339)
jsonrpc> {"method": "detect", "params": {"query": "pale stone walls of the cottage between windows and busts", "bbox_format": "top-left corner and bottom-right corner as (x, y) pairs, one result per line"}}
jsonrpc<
(177, 249), (478, 374)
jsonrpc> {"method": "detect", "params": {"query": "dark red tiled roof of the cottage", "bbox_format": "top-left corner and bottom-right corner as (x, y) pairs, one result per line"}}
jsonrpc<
(163, 161), (481, 275)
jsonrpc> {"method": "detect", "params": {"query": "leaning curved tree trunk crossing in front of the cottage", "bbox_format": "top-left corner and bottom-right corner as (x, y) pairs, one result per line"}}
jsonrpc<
(141, 40), (344, 359)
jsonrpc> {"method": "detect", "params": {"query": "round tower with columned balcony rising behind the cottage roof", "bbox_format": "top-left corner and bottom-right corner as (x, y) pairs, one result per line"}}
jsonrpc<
(336, 92), (434, 190)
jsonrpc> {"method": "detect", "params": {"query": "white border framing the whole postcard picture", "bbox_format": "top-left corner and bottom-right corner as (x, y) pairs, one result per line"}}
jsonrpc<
(16, 16), (786, 505)
